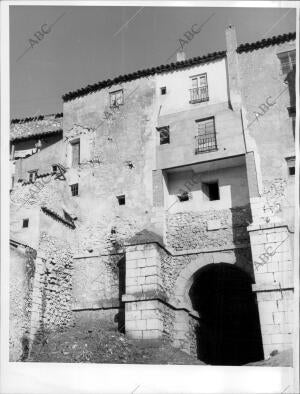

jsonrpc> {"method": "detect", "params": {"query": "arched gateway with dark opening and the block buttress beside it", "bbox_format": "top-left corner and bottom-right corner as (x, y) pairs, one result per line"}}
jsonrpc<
(122, 242), (263, 365)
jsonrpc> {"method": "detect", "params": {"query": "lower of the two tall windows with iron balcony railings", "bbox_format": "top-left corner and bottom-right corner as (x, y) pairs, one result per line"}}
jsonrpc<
(195, 117), (217, 154)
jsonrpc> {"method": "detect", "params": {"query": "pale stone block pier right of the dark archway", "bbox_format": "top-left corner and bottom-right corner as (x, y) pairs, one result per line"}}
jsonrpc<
(249, 223), (294, 357)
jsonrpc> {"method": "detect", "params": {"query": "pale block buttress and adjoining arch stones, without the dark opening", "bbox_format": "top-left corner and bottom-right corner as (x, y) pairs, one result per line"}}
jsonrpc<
(122, 237), (251, 358)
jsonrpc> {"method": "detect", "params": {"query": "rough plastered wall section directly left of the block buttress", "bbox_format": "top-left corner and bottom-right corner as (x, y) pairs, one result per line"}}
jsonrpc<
(72, 253), (125, 332)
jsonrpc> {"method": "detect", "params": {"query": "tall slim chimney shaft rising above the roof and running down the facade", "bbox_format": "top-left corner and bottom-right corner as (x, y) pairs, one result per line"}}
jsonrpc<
(225, 25), (242, 111)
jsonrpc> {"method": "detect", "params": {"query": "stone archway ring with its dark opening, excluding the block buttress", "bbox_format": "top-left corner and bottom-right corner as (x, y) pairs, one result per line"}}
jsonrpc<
(171, 255), (263, 365)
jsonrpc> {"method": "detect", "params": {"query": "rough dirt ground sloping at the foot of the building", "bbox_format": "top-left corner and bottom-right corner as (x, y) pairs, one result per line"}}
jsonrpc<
(26, 323), (293, 367)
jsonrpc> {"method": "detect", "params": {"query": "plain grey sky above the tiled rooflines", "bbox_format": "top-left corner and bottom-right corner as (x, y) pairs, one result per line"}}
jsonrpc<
(9, 5), (296, 119)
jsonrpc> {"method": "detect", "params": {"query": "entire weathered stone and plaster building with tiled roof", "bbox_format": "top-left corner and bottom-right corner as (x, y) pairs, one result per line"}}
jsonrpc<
(10, 26), (296, 365)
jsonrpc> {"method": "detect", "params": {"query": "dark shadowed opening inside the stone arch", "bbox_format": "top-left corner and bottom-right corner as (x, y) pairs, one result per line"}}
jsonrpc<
(189, 263), (263, 365)
